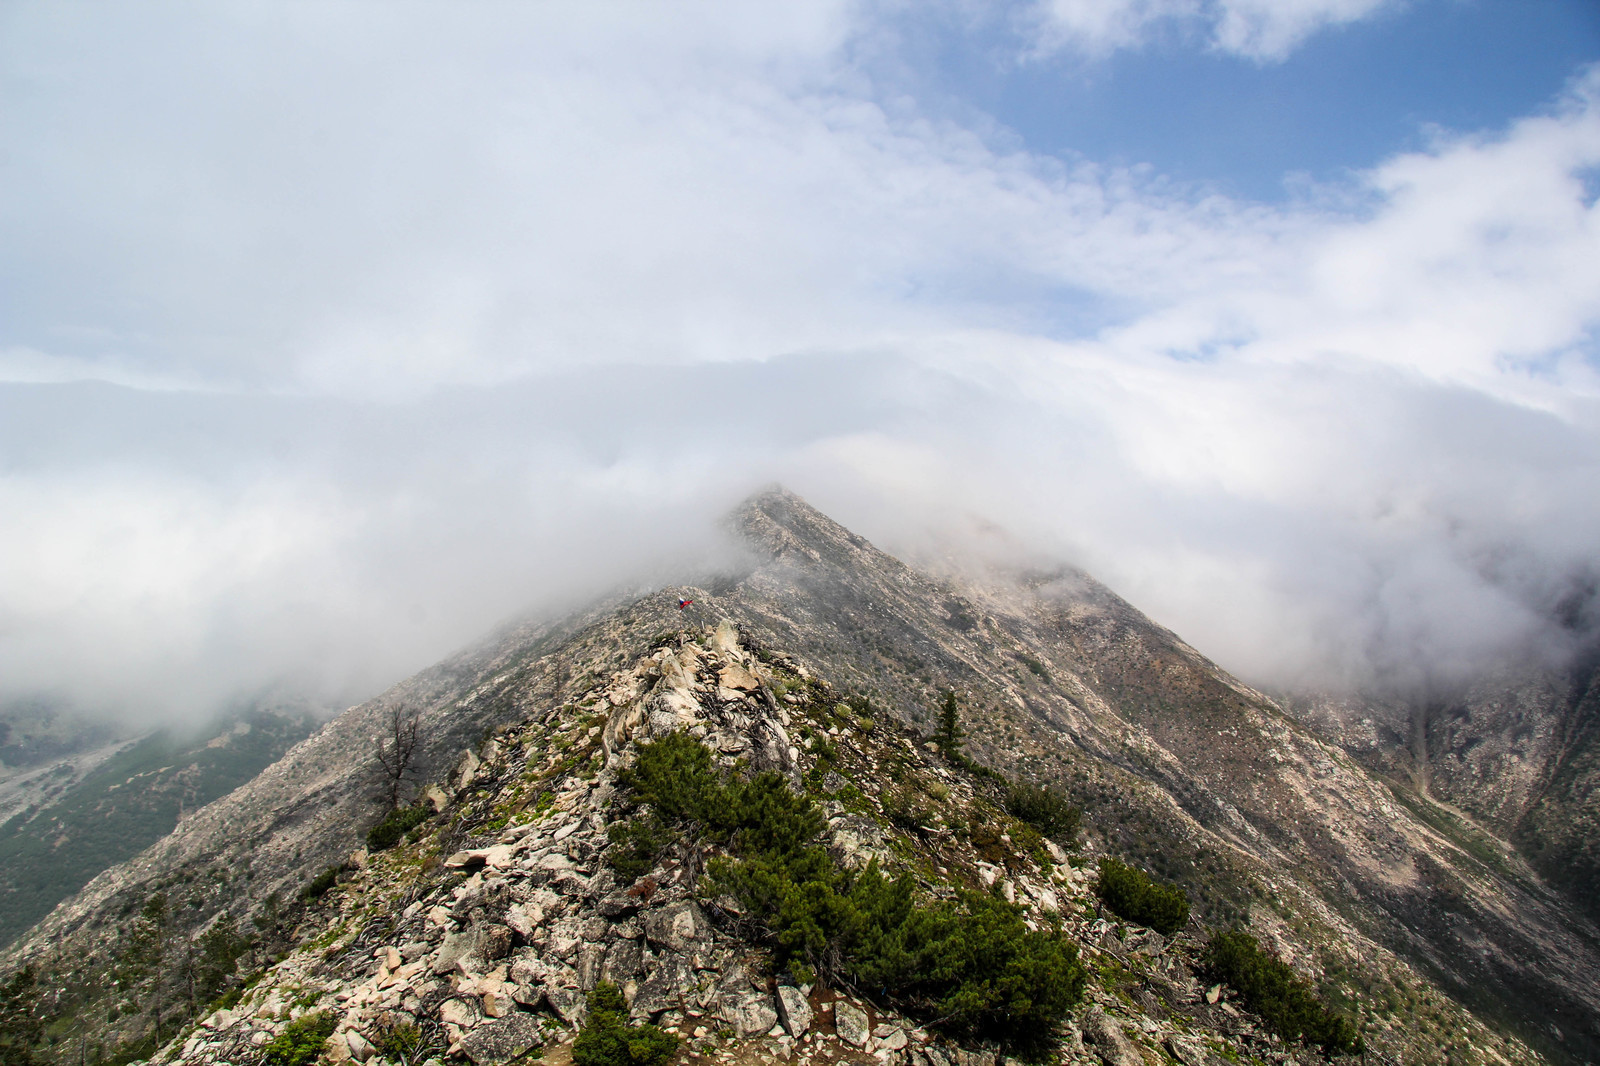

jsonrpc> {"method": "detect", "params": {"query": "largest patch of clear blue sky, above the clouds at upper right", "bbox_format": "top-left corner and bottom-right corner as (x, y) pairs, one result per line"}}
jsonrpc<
(906, 0), (1600, 202)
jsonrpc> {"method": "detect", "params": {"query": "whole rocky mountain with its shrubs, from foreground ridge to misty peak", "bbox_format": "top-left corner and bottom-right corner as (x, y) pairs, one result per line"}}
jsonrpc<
(0, 491), (1600, 1066)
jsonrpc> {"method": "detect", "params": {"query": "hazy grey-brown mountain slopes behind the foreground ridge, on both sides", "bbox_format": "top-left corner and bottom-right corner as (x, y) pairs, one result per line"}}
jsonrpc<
(10, 491), (1600, 1063)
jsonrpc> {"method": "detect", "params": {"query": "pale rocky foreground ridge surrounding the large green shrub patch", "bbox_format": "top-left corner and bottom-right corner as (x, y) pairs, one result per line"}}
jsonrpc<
(150, 623), (1376, 1066)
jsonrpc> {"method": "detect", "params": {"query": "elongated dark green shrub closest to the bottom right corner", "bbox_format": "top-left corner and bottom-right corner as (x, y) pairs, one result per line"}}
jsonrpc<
(1202, 930), (1365, 1055)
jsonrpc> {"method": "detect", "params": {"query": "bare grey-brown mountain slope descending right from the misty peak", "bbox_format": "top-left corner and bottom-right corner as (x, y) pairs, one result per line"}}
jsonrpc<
(726, 495), (1600, 1061)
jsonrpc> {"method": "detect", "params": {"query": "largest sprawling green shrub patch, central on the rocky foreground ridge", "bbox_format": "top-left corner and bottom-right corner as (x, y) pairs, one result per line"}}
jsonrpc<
(611, 733), (1086, 1060)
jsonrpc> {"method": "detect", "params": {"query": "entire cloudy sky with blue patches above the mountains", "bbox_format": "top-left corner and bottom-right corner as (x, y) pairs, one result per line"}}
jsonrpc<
(0, 0), (1600, 714)
